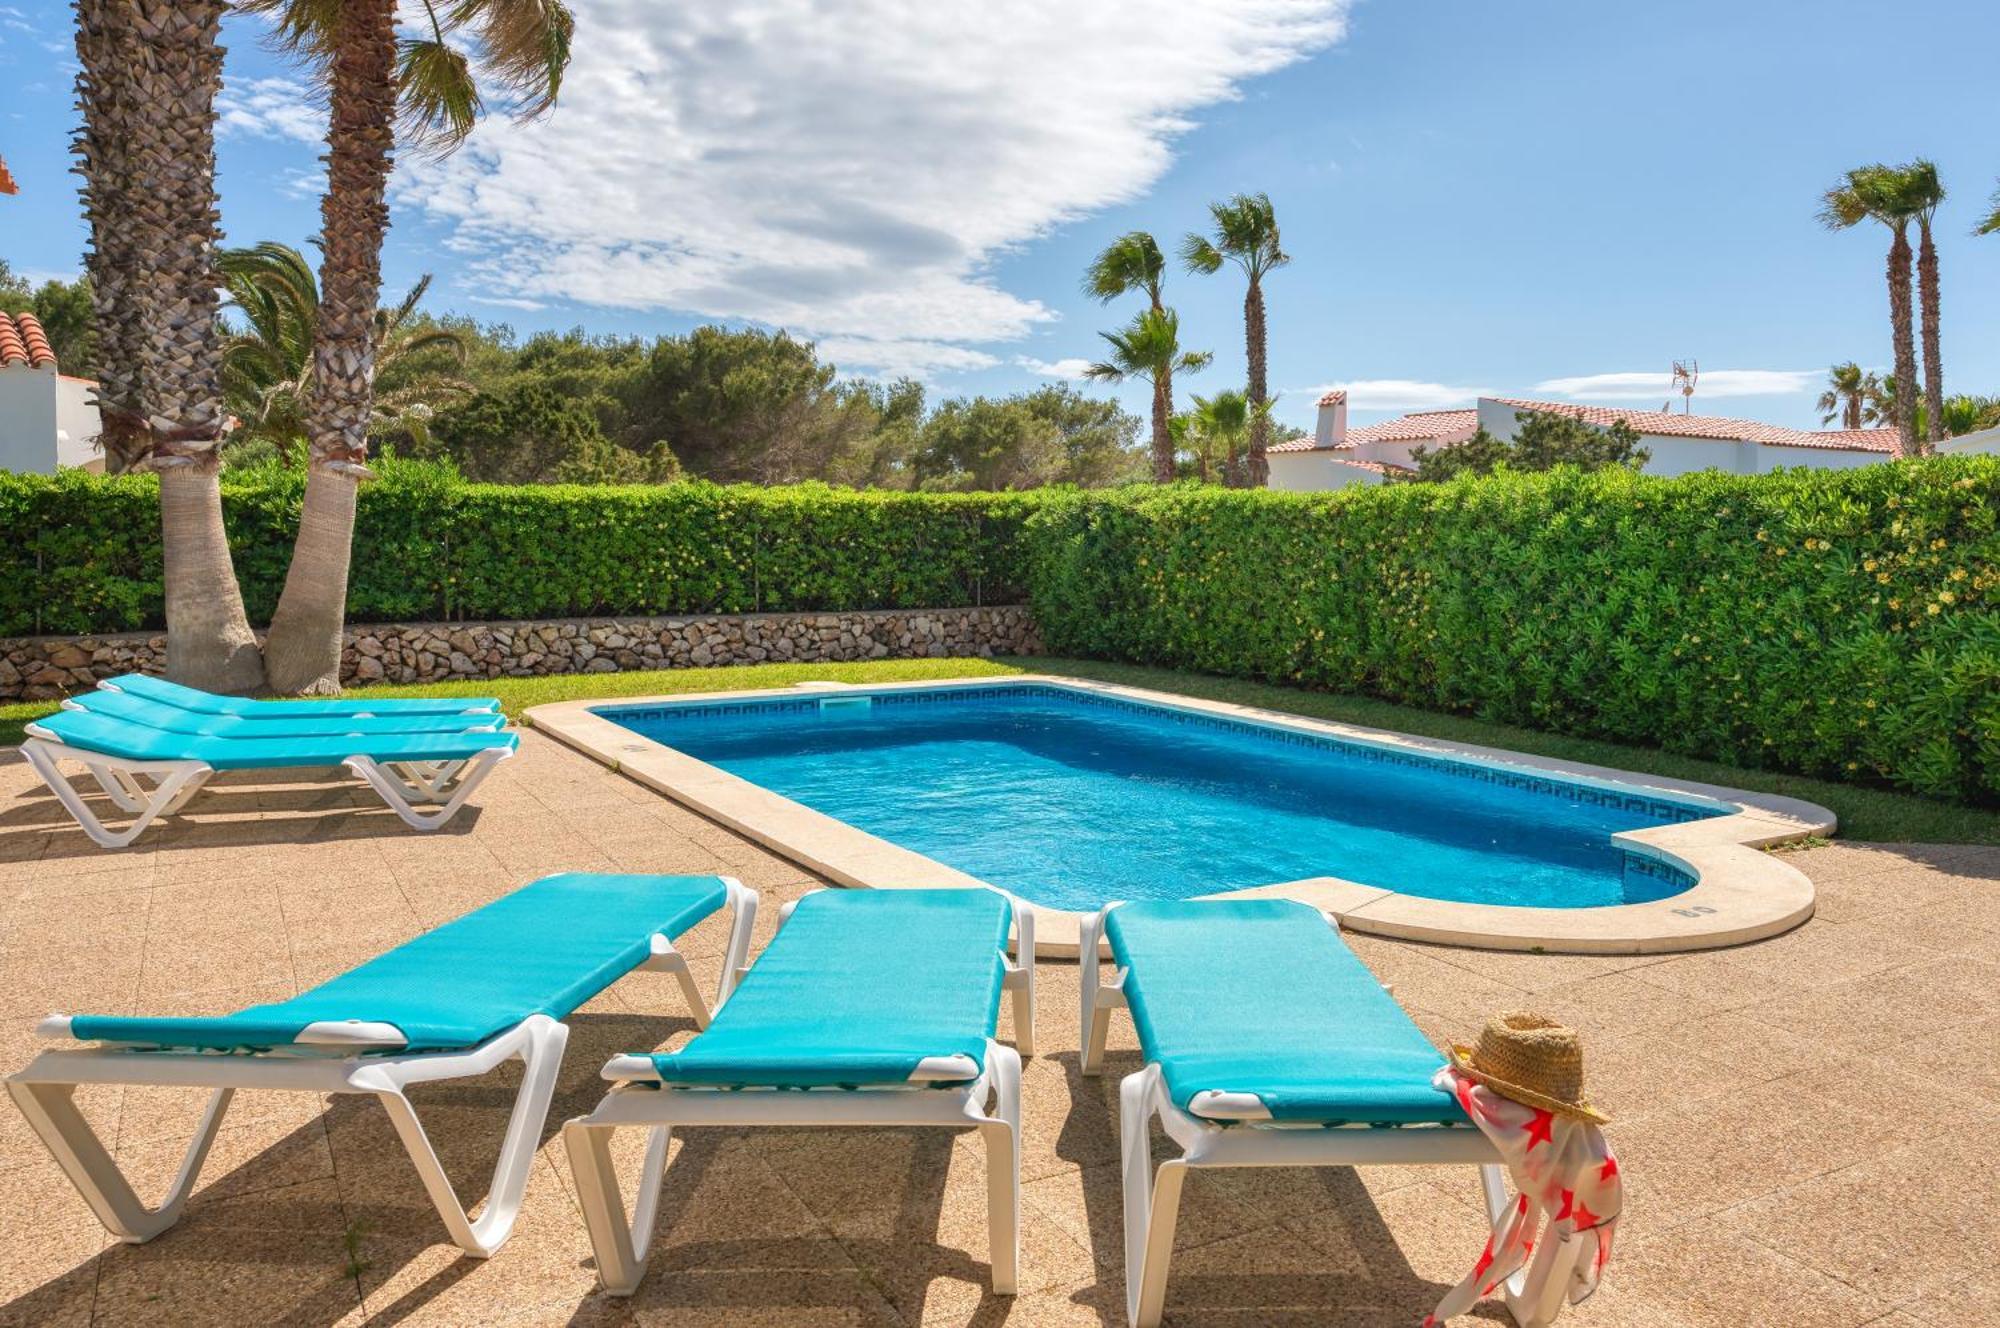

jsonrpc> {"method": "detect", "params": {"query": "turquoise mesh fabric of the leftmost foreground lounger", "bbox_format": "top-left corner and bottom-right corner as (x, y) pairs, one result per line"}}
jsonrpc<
(70, 872), (726, 1052)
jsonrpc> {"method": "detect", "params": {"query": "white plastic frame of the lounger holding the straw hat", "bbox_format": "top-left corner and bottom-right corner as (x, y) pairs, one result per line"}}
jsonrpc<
(1076, 904), (1584, 1328)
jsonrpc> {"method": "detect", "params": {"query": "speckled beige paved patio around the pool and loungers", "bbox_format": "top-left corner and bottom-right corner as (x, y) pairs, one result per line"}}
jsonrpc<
(0, 734), (2000, 1328)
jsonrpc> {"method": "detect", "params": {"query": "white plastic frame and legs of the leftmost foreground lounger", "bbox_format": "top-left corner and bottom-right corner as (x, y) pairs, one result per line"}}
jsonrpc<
(6, 876), (756, 1258)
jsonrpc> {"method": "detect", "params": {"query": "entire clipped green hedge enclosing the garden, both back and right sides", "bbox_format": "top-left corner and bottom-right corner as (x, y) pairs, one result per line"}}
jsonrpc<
(0, 458), (2000, 802)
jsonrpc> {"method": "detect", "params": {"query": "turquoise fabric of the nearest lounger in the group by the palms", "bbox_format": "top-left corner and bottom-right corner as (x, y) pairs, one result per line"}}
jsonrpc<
(30, 710), (520, 770)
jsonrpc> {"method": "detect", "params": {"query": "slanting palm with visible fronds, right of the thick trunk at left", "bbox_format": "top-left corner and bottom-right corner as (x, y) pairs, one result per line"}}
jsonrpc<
(238, 0), (574, 694)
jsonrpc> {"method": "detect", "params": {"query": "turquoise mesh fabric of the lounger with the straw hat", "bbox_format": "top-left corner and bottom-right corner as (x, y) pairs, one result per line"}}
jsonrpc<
(1104, 900), (1464, 1124)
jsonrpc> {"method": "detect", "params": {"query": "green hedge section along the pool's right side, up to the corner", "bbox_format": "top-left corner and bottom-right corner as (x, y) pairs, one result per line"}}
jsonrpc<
(1026, 458), (2000, 802)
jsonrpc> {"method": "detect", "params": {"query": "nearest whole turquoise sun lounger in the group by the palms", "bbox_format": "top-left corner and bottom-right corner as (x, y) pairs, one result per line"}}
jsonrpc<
(20, 710), (520, 848)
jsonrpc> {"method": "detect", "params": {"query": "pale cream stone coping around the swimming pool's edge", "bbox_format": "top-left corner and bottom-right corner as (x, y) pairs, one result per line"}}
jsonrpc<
(526, 674), (1838, 958)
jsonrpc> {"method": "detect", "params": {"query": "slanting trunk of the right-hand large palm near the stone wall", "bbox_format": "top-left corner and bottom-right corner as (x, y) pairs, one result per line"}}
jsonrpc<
(266, 0), (396, 696)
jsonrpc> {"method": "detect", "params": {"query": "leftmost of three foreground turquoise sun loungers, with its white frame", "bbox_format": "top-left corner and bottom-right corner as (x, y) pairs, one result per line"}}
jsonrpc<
(8, 872), (756, 1256)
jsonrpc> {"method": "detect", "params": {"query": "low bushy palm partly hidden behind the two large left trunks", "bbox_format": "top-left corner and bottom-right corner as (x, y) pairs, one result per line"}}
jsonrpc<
(218, 240), (472, 456)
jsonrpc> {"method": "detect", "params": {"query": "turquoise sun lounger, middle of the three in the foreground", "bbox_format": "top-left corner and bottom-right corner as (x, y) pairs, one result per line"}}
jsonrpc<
(562, 890), (1034, 1296)
